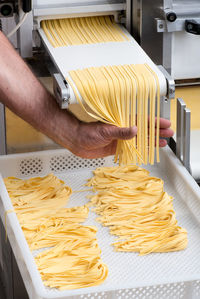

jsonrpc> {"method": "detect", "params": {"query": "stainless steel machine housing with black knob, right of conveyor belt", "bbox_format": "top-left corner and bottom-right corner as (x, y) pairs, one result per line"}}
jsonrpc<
(133, 0), (200, 83)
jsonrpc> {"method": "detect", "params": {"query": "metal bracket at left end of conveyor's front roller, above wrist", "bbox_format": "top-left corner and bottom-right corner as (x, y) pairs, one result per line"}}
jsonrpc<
(53, 73), (70, 109)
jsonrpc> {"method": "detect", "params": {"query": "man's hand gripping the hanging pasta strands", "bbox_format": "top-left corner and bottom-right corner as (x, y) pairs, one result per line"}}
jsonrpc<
(67, 118), (174, 159)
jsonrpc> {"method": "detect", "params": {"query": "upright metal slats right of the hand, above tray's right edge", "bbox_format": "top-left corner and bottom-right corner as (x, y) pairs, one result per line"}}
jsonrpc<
(176, 98), (191, 173)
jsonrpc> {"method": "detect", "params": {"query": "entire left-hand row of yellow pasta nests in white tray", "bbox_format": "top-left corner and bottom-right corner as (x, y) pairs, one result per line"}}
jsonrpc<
(4, 174), (108, 290)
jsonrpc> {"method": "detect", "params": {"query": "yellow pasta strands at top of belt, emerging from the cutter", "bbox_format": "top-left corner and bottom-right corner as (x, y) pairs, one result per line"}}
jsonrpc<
(41, 16), (128, 47)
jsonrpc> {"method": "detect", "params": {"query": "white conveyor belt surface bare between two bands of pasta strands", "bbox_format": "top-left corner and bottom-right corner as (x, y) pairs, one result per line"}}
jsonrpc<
(38, 26), (167, 101)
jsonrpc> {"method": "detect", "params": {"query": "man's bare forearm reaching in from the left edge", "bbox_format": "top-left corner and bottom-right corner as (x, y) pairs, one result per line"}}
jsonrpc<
(0, 32), (78, 148)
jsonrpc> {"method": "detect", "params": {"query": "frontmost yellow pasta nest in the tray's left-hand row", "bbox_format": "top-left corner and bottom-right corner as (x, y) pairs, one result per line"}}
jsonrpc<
(35, 239), (108, 290)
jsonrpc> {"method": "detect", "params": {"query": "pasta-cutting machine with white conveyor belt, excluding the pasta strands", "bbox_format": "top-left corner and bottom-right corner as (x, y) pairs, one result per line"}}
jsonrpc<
(0, 0), (175, 151)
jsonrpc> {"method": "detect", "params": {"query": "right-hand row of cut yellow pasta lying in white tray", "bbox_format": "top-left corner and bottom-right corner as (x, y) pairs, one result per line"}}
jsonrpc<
(87, 166), (187, 255)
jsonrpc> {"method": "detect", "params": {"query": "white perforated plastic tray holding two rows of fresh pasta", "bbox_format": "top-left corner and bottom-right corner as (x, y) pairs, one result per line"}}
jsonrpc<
(0, 147), (200, 299)
